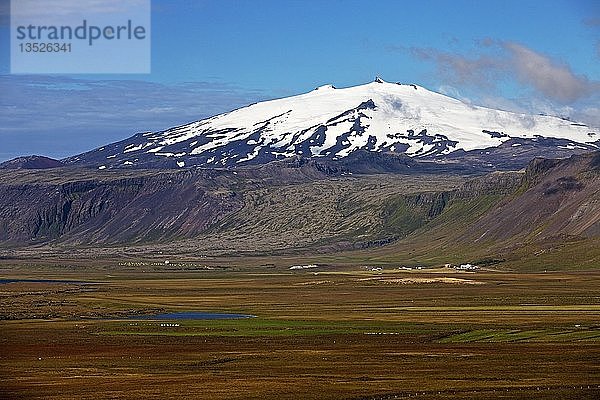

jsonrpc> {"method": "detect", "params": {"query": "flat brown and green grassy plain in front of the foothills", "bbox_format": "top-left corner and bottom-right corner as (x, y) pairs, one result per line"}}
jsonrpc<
(0, 264), (600, 399)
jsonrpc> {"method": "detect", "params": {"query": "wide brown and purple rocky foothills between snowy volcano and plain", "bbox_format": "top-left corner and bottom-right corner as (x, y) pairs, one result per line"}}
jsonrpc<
(0, 151), (600, 269)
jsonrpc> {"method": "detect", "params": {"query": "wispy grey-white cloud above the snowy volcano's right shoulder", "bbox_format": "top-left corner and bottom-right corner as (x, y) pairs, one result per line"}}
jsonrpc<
(398, 38), (600, 129)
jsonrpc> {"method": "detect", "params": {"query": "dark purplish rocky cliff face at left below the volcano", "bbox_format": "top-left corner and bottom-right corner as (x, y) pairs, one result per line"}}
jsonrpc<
(0, 171), (241, 244)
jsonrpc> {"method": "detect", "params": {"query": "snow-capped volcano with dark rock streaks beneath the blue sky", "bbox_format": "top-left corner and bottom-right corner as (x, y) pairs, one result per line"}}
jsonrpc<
(65, 78), (600, 169)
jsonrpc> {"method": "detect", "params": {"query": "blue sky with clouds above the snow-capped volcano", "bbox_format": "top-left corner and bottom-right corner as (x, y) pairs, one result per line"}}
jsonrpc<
(0, 0), (600, 160)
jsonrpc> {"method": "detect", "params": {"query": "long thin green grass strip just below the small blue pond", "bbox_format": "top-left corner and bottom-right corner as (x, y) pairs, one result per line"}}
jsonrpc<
(96, 318), (600, 343)
